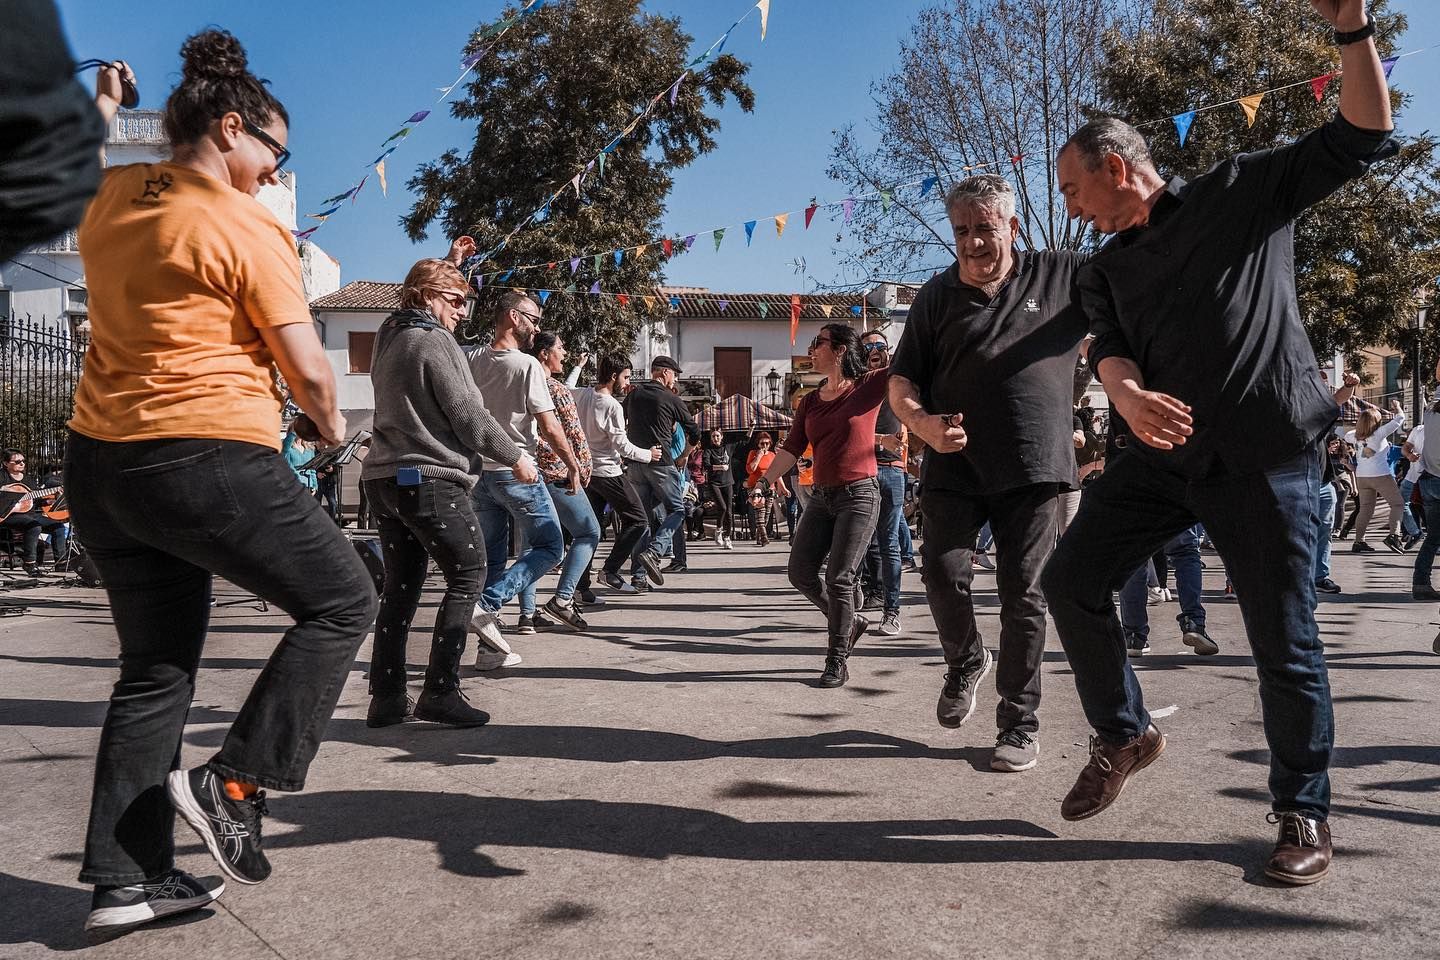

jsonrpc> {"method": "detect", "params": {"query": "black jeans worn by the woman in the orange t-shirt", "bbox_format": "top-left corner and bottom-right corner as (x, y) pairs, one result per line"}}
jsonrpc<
(65, 433), (376, 884)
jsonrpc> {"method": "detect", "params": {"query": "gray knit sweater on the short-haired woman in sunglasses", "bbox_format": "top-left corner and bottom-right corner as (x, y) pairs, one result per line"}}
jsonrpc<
(360, 309), (521, 489)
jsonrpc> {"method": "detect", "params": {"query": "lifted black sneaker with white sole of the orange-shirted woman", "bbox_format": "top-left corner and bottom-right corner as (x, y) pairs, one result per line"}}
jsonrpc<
(166, 766), (271, 884)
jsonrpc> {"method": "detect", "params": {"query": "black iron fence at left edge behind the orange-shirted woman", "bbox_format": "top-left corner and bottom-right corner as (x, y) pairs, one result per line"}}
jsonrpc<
(0, 315), (85, 475)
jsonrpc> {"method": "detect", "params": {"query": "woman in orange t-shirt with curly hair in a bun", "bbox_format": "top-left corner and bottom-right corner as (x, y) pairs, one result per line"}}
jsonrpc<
(65, 30), (376, 933)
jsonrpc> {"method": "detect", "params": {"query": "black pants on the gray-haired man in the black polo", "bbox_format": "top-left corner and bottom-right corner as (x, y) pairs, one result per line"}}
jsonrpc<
(920, 484), (1060, 733)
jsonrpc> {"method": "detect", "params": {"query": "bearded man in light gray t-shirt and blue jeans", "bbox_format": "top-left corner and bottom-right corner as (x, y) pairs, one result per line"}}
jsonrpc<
(469, 291), (580, 656)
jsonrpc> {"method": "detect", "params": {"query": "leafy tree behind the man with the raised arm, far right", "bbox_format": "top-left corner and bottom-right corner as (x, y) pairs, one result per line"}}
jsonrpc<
(1099, 0), (1440, 367)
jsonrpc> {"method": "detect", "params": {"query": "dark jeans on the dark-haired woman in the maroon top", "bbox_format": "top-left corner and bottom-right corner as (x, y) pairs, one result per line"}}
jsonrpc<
(789, 476), (880, 651)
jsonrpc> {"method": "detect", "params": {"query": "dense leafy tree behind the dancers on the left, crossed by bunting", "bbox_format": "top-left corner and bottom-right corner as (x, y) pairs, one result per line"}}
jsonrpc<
(402, 0), (755, 353)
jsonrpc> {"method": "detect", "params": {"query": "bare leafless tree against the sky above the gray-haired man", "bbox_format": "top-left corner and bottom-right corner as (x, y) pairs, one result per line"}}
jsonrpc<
(828, 0), (1148, 278)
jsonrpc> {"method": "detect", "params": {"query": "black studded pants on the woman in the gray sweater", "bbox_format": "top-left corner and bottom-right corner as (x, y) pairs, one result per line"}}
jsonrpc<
(364, 478), (485, 697)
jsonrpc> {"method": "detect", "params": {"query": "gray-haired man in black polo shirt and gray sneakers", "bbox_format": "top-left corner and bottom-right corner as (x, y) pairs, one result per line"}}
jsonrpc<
(890, 174), (1086, 771)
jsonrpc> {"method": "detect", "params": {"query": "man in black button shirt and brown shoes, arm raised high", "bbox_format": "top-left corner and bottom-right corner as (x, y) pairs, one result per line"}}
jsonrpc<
(1044, 0), (1394, 884)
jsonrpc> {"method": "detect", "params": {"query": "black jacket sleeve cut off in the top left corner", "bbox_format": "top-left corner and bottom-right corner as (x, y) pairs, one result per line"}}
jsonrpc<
(0, 0), (105, 261)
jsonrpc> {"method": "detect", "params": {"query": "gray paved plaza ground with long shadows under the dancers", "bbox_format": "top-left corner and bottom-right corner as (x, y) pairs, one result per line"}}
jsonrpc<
(0, 543), (1440, 960)
